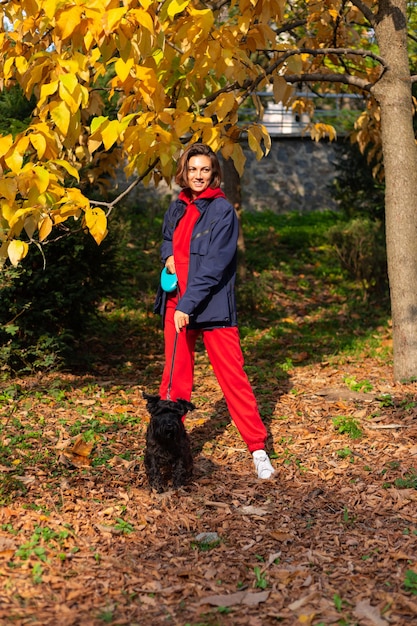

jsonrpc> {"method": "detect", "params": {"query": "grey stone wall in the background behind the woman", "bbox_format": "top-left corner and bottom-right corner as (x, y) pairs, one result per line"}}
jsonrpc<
(131, 137), (337, 213)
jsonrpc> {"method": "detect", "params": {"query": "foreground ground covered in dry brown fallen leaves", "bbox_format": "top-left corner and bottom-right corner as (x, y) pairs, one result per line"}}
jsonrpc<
(0, 330), (417, 626)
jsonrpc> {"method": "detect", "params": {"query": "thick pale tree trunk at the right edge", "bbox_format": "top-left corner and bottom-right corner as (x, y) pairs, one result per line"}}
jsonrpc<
(372, 0), (417, 381)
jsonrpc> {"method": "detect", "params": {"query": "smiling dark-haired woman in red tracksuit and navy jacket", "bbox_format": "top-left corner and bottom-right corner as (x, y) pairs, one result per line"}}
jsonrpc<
(155, 143), (274, 479)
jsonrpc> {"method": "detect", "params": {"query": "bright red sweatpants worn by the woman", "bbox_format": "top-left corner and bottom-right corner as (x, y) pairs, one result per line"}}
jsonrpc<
(159, 305), (267, 452)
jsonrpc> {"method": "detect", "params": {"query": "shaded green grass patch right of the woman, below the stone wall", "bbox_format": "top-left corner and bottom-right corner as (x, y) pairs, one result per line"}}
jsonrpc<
(238, 213), (389, 368)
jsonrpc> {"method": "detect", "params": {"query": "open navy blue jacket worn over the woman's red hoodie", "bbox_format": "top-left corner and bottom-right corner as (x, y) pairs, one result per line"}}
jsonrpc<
(154, 192), (239, 328)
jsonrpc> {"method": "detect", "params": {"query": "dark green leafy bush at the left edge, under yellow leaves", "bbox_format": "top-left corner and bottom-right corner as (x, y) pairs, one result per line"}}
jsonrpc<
(0, 218), (121, 373)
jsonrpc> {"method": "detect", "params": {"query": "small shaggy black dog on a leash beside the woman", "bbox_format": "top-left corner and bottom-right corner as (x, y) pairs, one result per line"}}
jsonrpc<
(143, 393), (195, 493)
